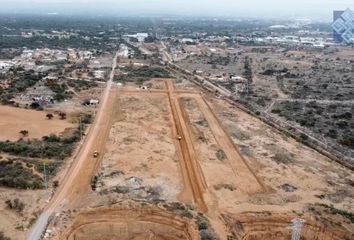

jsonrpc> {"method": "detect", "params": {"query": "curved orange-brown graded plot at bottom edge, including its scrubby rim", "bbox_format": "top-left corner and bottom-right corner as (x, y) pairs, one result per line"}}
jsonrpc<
(53, 201), (205, 240)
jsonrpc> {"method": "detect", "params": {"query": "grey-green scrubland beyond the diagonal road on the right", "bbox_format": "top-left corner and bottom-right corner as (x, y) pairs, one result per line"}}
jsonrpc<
(177, 46), (354, 165)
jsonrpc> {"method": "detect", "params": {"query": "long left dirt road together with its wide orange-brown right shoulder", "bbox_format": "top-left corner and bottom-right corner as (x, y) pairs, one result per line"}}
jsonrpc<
(27, 52), (118, 240)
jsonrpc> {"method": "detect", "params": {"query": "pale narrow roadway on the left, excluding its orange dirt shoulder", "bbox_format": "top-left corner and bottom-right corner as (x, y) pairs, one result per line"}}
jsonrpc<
(27, 52), (118, 240)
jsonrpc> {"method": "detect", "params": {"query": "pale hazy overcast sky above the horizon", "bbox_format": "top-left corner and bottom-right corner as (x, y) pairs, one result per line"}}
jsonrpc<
(0, 0), (354, 20)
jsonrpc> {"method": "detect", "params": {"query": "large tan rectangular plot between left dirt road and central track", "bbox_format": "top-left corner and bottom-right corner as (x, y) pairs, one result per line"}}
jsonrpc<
(98, 94), (182, 201)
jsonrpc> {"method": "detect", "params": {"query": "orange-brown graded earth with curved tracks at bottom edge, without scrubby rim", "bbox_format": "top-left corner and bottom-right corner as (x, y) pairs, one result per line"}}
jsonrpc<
(59, 204), (199, 240)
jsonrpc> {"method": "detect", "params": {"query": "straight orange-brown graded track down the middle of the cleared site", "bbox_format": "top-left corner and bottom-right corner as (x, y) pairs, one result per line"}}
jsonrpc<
(165, 80), (208, 212)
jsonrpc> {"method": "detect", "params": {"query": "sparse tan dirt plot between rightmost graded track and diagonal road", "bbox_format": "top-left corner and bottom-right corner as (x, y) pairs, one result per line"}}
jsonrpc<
(208, 96), (354, 234)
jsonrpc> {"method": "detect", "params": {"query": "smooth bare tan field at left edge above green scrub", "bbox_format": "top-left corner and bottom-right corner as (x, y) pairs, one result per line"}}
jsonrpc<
(0, 105), (75, 141)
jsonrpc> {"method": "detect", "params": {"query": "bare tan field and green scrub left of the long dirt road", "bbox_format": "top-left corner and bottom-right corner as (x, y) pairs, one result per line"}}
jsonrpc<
(0, 105), (86, 240)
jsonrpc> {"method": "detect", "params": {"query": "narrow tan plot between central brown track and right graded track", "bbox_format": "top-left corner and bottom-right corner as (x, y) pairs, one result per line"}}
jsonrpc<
(181, 95), (264, 207)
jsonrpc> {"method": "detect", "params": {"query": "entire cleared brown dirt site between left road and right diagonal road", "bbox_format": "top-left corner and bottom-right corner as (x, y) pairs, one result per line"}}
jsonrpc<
(42, 80), (354, 240)
